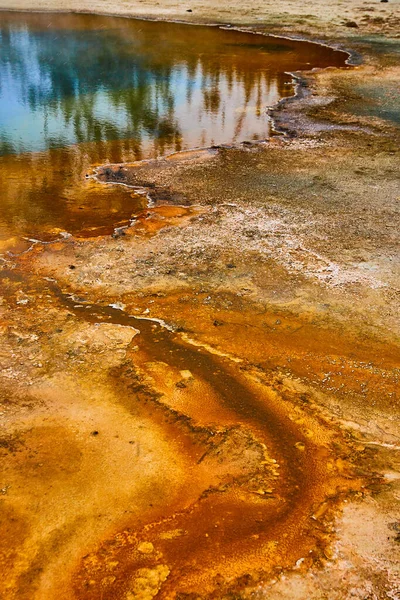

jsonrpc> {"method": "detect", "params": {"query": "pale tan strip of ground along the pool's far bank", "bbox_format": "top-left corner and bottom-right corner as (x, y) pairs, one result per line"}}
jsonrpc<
(1, 0), (400, 37)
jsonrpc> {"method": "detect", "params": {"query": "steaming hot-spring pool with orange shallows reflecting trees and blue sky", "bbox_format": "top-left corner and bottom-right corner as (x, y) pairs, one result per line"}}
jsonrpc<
(0, 13), (347, 240)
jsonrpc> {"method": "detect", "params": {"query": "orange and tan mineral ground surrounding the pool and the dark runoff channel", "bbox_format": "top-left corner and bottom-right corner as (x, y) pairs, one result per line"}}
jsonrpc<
(1, 0), (400, 600)
